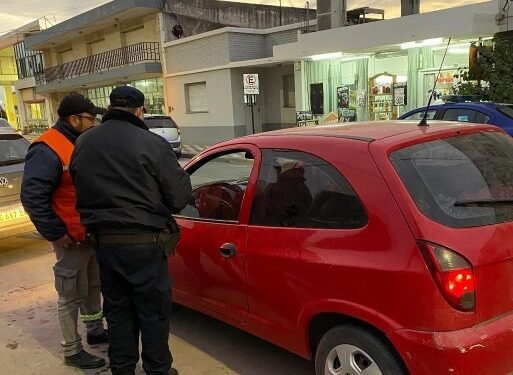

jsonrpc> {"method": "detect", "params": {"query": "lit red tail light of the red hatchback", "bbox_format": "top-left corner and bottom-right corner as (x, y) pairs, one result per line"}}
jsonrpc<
(418, 241), (475, 311)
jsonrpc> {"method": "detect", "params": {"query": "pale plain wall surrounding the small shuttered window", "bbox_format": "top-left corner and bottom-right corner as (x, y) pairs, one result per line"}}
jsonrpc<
(166, 69), (235, 145)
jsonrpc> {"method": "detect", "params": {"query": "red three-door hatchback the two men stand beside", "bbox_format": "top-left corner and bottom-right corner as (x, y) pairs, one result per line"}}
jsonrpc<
(169, 121), (513, 375)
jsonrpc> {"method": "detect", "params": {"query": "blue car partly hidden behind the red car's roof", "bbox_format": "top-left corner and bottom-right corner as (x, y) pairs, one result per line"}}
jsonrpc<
(399, 102), (513, 136)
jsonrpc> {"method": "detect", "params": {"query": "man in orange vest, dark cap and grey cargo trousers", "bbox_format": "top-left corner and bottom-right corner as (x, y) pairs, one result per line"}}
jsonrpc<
(21, 94), (108, 369)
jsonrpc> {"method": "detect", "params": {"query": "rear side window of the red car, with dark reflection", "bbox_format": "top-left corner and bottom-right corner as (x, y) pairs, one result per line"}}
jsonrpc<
(250, 149), (367, 229)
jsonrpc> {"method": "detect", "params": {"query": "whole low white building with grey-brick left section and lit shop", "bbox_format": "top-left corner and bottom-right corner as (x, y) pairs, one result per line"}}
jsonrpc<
(164, 0), (508, 145)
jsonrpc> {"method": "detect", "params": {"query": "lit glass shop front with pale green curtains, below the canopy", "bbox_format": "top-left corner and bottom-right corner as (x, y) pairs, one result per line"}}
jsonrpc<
(301, 38), (478, 123)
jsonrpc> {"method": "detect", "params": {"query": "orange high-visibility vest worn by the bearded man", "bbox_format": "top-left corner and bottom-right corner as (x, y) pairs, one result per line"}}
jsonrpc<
(34, 128), (85, 241)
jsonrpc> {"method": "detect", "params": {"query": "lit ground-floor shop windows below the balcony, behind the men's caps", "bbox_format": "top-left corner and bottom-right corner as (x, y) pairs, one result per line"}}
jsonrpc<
(84, 78), (165, 114)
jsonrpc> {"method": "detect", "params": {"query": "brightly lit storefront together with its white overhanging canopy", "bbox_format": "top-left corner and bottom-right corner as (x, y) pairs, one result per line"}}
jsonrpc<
(273, 1), (498, 124)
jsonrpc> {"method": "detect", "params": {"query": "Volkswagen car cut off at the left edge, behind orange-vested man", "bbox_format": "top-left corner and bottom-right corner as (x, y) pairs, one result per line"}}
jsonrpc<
(0, 128), (34, 238)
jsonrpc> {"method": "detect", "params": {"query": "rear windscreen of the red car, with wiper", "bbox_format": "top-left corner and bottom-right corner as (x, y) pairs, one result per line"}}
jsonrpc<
(390, 132), (513, 228)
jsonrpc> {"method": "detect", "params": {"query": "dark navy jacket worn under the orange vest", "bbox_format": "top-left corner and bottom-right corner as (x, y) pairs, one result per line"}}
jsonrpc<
(20, 120), (79, 241)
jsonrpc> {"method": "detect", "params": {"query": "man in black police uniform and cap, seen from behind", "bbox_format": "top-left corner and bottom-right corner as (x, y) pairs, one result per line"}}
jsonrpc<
(71, 86), (191, 375)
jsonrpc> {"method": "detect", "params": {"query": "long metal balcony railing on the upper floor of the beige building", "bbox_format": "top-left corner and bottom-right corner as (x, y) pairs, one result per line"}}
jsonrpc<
(36, 42), (160, 85)
